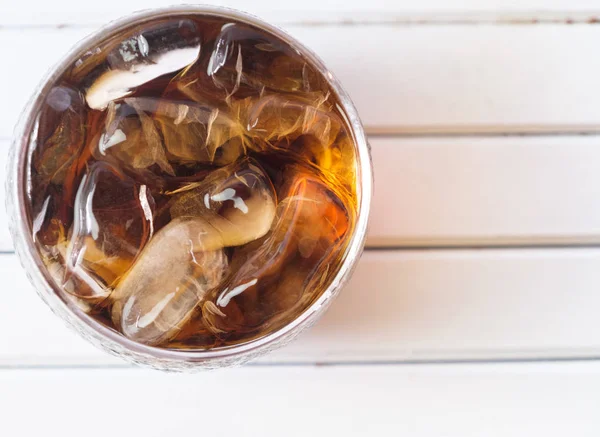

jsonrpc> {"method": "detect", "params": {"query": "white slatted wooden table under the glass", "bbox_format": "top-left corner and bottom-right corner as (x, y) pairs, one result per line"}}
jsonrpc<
(0, 0), (600, 437)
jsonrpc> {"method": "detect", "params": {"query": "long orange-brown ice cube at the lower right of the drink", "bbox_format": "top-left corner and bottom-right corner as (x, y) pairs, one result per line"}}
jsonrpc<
(203, 167), (352, 335)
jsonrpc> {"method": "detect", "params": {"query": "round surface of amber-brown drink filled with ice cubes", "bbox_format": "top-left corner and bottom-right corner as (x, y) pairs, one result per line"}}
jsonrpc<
(26, 15), (359, 350)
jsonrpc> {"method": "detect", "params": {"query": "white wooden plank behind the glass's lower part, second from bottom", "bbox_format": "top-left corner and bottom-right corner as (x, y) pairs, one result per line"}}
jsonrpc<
(0, 249), (600, 366)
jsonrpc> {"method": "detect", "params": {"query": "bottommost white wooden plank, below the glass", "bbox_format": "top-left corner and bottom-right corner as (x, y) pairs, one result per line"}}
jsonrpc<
(0, 362), (600, 437)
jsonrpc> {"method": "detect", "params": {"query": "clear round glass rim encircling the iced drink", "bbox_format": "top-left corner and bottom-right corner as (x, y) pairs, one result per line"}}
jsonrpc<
(6, 5), (373, 367)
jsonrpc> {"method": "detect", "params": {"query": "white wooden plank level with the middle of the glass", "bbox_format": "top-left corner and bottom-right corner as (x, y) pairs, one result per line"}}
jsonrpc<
(0, 136), (600, 251)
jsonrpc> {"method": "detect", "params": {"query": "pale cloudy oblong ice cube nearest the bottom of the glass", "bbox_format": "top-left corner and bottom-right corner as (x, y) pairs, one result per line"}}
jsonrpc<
(111, 218), (228, 345)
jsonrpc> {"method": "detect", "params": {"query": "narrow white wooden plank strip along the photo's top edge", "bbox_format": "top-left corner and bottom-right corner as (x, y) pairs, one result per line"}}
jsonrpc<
(0, 0), (599, 26)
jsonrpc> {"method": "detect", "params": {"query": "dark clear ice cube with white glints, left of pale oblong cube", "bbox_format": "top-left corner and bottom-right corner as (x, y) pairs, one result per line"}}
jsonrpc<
(57, 162), (154, 298)
